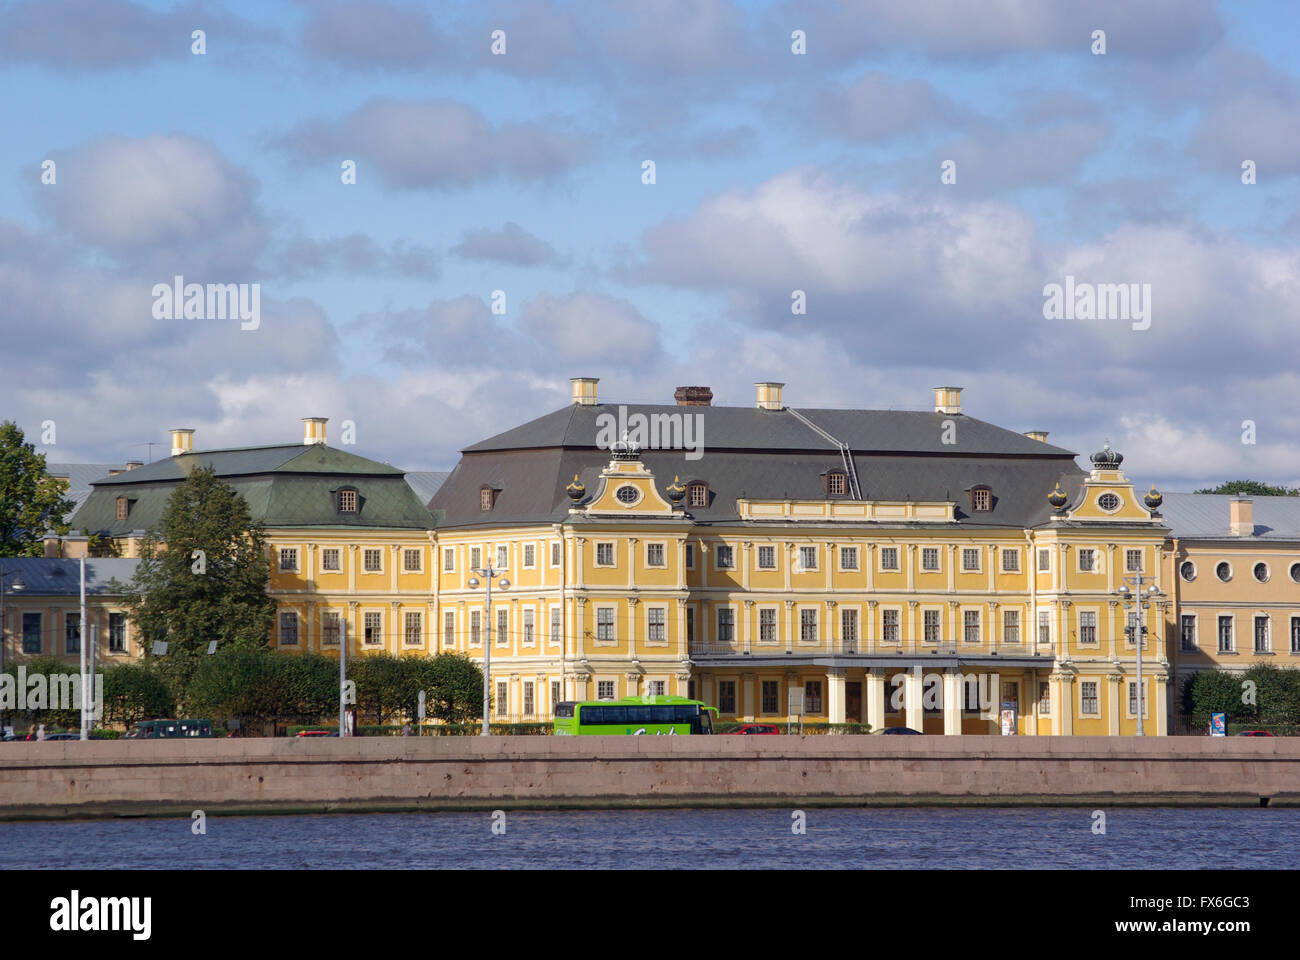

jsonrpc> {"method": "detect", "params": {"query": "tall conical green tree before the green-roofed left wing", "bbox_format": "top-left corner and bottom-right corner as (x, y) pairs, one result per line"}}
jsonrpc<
(124, 468), (276, 704)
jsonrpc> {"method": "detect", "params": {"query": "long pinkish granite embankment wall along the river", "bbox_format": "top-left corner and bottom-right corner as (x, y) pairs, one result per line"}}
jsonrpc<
(0, 736), (1300, 818)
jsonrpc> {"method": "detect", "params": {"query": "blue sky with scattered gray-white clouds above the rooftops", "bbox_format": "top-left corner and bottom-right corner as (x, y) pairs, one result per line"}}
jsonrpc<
(0, 0), (1300, 489)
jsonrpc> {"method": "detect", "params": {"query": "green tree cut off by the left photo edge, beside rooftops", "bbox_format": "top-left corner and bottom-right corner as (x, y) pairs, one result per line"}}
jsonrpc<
(0, 420), (73, 557)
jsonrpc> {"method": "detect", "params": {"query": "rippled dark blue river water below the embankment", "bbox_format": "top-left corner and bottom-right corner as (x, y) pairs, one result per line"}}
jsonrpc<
(0, 808), (1300, 869)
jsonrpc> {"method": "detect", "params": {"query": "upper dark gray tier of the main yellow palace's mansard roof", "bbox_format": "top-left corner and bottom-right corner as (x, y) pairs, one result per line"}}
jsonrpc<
(463, 403), (1075, 458)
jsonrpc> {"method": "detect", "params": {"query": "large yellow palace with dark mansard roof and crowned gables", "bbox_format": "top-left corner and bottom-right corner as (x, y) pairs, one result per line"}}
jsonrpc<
(429, 377), (1170, 735)
